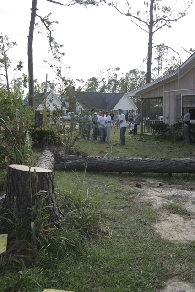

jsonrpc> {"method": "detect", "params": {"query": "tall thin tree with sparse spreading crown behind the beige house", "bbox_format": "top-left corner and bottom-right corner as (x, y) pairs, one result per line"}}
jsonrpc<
(108, 0), (193, 83)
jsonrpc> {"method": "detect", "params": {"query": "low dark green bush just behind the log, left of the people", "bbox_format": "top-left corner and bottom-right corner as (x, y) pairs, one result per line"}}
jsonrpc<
(29, 127), (61, 147)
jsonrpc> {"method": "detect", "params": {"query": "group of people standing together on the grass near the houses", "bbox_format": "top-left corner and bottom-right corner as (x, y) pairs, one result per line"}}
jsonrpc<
(80, 109), (141, 146)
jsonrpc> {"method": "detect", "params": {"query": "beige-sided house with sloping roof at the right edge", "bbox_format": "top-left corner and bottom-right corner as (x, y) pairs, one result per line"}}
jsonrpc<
(128, 53), (195, 130)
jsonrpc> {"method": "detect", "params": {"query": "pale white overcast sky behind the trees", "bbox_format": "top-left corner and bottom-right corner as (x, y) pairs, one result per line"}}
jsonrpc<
(0, 0), (195, 88)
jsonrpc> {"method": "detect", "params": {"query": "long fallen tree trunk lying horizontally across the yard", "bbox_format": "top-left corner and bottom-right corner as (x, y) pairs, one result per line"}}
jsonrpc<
(55, 154), (195, 173)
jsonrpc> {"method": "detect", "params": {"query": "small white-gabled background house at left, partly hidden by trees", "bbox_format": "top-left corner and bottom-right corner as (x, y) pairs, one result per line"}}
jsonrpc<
(23, 91), (62, 112)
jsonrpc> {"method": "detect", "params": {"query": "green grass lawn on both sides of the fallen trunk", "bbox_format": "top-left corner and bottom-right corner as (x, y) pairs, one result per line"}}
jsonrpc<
(0, 129), (195, 292)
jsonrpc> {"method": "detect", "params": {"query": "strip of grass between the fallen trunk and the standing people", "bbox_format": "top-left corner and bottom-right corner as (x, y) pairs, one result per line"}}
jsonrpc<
(76, 129), (195, 158)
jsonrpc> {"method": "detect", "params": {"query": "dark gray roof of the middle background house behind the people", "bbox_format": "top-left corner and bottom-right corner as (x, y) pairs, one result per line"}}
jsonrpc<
(76, 92), (125, 110)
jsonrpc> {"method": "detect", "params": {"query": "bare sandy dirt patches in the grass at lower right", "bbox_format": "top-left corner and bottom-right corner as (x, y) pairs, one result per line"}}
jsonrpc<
(128, 179), (195, 292)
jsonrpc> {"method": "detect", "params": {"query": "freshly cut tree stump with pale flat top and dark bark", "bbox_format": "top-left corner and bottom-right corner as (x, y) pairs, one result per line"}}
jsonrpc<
(4, 164), (60, 225)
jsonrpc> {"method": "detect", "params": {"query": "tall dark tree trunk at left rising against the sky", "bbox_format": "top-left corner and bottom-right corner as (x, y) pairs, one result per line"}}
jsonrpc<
(28, 0), (37, 106)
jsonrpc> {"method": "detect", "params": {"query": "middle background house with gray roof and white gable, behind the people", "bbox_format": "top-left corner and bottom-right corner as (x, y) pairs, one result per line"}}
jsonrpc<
(75, 92), (137, 113)
